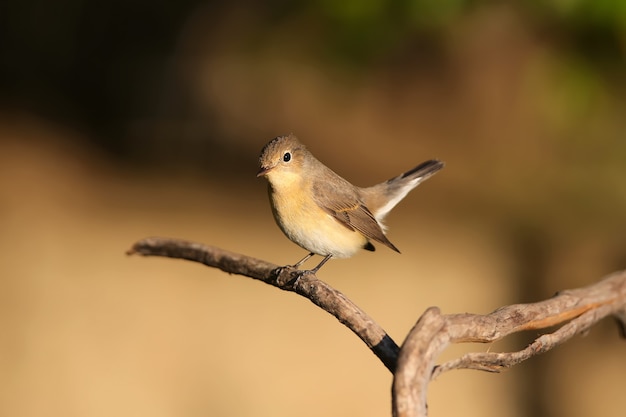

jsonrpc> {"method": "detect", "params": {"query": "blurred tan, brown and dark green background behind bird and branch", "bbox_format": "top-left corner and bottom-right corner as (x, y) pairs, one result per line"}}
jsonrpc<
(0, 0), (626, 417)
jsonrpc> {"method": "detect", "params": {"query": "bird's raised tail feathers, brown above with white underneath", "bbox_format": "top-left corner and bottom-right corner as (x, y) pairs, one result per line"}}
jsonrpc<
(362, 159), (445, 221)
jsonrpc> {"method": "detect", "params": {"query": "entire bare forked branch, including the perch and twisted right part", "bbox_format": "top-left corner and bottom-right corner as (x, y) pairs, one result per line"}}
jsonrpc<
(127, 238), (626, 417)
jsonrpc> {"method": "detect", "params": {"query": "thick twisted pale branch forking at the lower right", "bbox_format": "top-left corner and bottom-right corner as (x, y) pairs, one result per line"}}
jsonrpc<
(393, 272), (626, 417)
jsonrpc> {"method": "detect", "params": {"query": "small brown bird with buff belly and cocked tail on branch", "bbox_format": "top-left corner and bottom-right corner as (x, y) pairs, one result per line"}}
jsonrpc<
(257, 135), (444, 273)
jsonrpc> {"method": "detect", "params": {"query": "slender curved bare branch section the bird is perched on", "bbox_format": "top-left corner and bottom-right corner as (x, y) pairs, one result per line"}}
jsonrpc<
(127, 237), (400, 372)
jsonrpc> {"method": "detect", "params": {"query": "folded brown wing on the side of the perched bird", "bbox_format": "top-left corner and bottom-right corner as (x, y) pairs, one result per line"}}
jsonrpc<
(313, 181), (400, 252)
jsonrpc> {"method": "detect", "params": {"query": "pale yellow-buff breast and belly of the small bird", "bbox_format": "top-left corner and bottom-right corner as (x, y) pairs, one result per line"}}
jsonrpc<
(271, 188), (367, 258)
